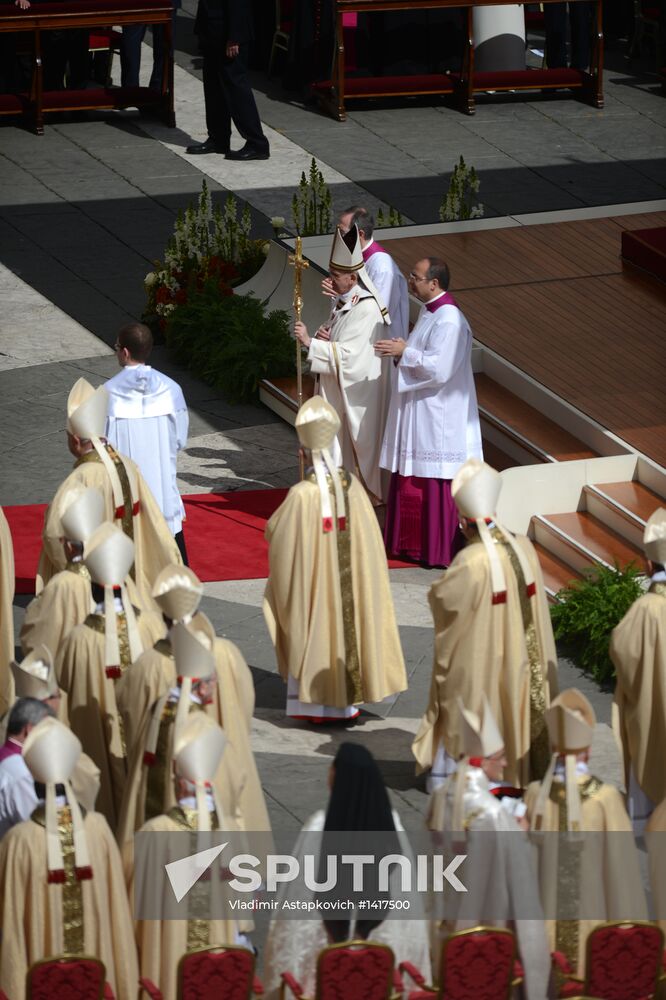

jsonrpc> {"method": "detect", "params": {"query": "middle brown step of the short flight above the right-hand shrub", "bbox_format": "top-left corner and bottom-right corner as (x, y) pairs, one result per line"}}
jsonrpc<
(530, 511), (644, 572)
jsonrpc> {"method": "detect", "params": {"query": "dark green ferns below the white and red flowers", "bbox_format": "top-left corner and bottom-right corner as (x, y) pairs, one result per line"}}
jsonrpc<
(166, 278), (296, 403)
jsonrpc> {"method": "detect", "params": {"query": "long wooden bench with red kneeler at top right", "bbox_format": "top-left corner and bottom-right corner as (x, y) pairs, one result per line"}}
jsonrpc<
(313, 0), (604, 121)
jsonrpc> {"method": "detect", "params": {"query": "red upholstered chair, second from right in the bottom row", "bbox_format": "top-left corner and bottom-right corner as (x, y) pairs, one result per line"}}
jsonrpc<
(400, 927), (523, 1000)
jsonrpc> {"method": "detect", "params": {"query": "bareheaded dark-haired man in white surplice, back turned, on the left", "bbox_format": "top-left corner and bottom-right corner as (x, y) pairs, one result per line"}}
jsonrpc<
(105, 323), (189, 553)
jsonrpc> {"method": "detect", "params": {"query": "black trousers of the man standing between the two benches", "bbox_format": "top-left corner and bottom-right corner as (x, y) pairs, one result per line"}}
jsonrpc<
(199, 36), (269, 153)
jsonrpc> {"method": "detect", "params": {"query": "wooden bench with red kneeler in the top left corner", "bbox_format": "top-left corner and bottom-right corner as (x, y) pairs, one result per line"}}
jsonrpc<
(0, 0), (176, 135)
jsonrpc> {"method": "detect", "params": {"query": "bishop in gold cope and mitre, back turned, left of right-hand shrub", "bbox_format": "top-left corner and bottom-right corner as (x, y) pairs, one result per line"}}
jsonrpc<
(412, 458), (557, 788)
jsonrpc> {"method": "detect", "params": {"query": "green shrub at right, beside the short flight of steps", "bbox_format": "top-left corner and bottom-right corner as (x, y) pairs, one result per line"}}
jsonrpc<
(550, 563), (643, 683)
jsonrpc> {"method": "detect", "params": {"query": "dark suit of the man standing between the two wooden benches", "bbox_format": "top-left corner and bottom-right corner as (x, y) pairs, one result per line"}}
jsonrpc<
(194, 0), (269, 153)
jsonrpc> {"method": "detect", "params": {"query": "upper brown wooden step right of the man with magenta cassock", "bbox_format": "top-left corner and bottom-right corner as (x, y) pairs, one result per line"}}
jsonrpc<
(474, 372), (597, 462)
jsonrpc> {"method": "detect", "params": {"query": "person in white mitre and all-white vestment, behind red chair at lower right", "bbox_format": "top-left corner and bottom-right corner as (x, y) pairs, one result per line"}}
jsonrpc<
(427, 696), (550, 1000)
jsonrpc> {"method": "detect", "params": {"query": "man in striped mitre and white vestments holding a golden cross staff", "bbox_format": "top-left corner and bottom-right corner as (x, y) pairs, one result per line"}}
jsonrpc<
(294, 226), (390, 503)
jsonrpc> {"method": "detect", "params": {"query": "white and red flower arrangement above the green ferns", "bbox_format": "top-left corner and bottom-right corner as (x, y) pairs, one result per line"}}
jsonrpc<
(143, 180), (268, 332)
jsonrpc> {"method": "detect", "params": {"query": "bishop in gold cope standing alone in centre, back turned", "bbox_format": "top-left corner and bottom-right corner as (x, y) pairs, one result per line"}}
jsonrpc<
(264, 396), (407, 722)
